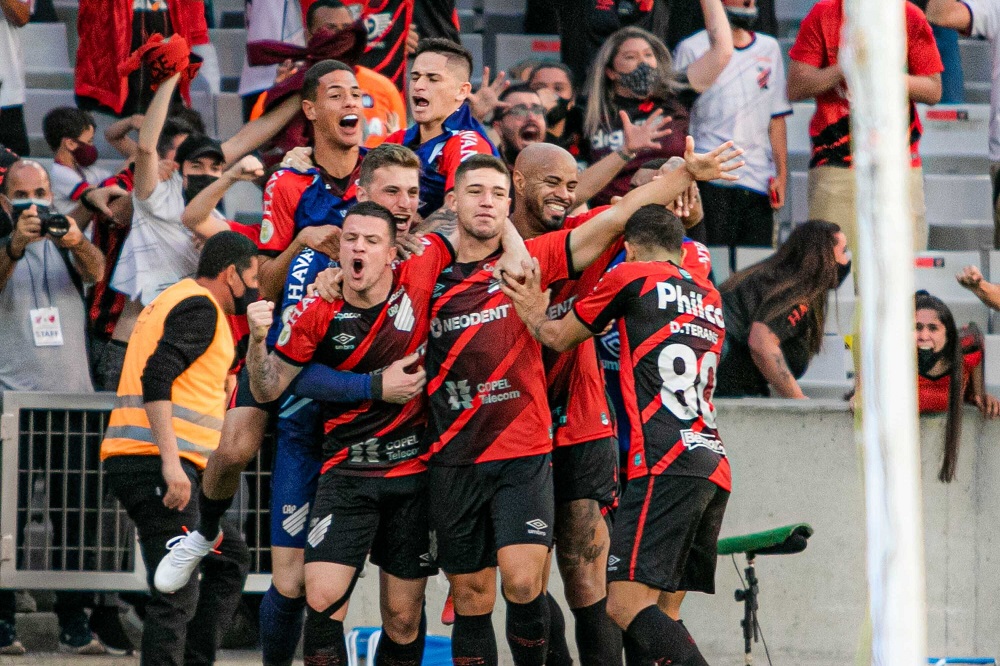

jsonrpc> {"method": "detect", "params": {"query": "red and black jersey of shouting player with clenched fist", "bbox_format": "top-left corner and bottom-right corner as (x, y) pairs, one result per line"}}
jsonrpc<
(274, 235), (454, 476)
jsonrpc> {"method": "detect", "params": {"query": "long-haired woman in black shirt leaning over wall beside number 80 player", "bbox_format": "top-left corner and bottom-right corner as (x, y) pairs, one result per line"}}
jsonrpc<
(715, 220), (851, 398)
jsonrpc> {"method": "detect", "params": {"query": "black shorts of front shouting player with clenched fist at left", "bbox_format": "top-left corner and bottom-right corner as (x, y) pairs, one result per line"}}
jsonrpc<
(305, 473), (437, 579)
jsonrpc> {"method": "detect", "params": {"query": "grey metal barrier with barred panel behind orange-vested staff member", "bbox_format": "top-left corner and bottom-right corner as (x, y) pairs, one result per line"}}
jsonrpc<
(0, 392), (271, 592)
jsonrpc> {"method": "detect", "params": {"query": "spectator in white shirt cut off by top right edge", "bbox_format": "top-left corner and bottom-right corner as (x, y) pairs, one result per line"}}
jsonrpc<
(926, 0), (1000, 249)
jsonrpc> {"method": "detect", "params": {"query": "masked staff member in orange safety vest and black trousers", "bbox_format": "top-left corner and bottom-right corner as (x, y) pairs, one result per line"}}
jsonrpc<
(101, 231), (257, 666)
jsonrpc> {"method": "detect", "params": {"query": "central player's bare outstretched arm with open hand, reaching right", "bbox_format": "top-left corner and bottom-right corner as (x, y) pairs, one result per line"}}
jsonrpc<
(570, 136), (743, 271)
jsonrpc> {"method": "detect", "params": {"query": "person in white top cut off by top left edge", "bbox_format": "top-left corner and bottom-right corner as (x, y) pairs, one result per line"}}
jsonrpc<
(0, 0), (31, 155)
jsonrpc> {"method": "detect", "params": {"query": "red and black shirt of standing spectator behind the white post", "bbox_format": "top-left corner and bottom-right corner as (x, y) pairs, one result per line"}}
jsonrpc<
(789, 0), (944, 167)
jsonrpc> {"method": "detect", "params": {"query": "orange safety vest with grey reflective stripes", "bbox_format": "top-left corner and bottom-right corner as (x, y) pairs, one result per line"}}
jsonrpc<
(101, 278), (235, 469)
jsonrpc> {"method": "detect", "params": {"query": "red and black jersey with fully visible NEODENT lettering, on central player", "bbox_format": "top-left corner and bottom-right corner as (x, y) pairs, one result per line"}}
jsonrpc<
(427, 231), (572, 466)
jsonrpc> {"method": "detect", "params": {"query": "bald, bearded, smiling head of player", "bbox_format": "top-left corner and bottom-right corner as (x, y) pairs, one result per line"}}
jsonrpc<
(513, 143), (578, 236)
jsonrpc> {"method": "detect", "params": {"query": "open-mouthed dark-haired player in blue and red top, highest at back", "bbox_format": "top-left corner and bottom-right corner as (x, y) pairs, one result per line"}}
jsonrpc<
(386, 38), (499, 217)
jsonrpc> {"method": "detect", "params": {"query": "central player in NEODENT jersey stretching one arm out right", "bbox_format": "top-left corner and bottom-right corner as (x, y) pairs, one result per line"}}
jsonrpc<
(427, 146), (739, 664)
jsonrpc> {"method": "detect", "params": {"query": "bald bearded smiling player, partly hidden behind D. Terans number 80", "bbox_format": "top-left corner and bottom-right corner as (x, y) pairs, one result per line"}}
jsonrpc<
(512, 137), (738, 666)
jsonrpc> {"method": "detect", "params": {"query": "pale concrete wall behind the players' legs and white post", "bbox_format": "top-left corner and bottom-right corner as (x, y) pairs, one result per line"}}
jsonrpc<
(348, 400), (1000, 666)
